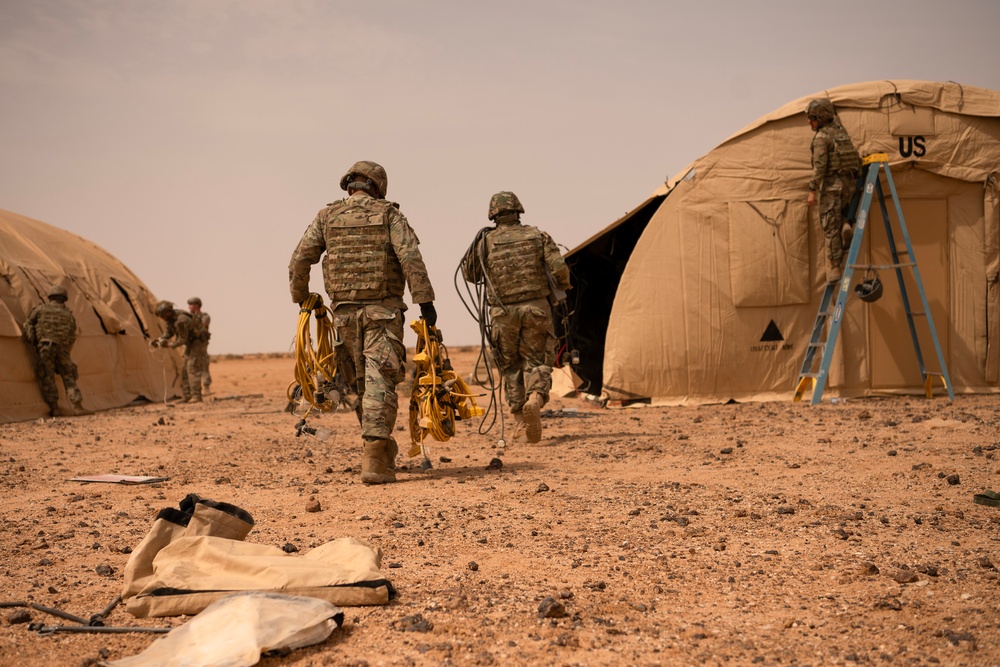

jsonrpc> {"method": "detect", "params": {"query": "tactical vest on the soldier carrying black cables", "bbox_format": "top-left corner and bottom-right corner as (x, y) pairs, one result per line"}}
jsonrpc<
(486, 225), (549, 306)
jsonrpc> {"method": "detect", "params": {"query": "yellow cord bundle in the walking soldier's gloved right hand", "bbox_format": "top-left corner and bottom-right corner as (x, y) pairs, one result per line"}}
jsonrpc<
(408, 318), (483, 456)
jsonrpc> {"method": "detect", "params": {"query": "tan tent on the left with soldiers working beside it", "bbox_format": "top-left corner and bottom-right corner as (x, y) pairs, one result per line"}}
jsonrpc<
(0, 209), (178, 423)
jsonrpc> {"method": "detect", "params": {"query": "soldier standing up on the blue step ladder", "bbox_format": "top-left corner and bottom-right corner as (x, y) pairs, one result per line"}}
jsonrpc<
(806, 97), (861, 282)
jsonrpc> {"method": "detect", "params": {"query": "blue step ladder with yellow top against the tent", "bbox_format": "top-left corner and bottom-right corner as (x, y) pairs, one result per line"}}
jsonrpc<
(792, 153), (955, 405)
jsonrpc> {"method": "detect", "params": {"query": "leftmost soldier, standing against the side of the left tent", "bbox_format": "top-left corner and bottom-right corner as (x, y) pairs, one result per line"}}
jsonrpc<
(24, 285), (93, 417)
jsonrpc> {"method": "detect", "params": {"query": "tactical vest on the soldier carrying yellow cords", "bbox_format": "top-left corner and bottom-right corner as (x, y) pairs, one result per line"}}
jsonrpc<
(323, 198), (406, 302)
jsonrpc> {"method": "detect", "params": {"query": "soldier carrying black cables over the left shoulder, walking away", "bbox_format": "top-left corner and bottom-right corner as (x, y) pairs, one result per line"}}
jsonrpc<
(462, 192), (570, 443)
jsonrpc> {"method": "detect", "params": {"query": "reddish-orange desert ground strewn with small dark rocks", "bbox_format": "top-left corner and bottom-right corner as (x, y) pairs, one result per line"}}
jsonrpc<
(0, 350), (1000, 667)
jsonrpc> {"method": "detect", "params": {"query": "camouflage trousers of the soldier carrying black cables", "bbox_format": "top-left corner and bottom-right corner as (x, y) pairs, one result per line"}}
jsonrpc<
(490, 299), (556, 413)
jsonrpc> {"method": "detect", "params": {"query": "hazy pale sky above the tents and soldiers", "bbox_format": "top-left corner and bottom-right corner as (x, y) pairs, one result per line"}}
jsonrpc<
(0, 0), (1000, 354)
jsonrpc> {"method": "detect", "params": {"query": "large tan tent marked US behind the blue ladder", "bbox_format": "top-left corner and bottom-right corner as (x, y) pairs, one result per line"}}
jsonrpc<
(568, 81), (1000, 404)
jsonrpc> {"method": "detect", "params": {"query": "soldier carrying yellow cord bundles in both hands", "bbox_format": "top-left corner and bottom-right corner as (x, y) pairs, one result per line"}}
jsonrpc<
(288, 161), (437, 484)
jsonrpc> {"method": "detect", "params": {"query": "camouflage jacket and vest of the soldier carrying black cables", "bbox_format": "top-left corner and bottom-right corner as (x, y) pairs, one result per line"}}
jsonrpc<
(462, 216), (570, 306)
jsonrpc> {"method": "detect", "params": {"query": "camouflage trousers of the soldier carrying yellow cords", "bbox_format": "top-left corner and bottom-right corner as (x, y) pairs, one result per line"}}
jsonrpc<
(333, 304), (406, 440)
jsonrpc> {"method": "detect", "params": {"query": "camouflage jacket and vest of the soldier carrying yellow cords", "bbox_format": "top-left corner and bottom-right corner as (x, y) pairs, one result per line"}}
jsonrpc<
(288, 192), (434, 308)
